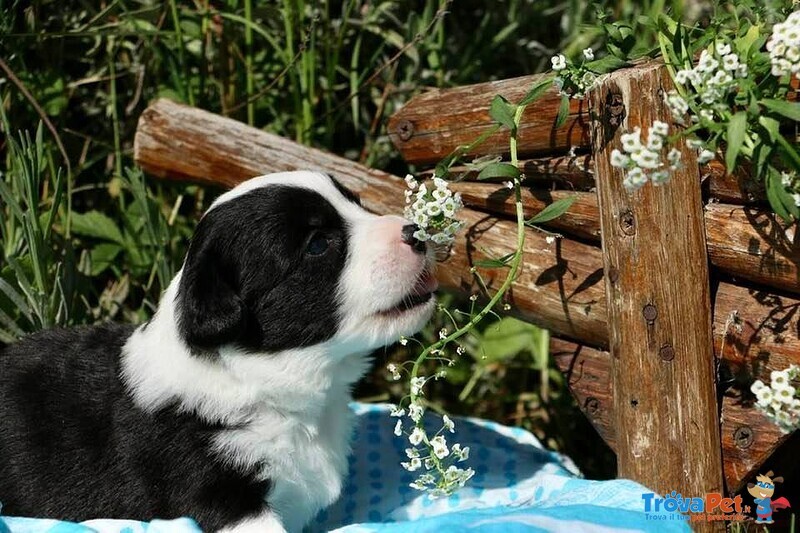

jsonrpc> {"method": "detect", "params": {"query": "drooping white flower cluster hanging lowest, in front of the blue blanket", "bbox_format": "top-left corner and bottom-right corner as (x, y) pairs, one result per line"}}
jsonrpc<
(390, 390), (475, 498)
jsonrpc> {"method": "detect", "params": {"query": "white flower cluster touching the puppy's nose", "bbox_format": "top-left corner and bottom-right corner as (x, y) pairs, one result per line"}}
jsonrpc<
(405, 174), (463, 245)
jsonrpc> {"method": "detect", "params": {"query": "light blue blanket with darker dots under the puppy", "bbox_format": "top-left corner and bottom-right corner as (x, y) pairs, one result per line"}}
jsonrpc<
(0, 404), (690, 533)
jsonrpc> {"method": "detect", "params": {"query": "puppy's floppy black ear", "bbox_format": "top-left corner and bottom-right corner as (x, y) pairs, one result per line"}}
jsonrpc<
(175, 217), (245, 350)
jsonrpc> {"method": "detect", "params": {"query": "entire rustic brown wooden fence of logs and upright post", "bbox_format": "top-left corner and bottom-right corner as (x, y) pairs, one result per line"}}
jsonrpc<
(135, 64), (800, 527)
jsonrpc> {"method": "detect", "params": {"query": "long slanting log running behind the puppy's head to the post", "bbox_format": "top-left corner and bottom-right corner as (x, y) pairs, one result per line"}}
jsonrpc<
(134, 100), (607, 345)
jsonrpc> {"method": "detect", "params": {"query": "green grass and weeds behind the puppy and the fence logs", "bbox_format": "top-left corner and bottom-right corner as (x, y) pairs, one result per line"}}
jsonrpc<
(0, 0), (696, 477)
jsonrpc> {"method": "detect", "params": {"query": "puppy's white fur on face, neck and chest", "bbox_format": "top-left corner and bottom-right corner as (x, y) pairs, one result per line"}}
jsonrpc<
(122, 172), (435, 532)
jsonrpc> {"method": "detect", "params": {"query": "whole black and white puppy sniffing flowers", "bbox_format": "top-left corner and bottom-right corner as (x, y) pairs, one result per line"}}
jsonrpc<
(0, 172), (436, 532)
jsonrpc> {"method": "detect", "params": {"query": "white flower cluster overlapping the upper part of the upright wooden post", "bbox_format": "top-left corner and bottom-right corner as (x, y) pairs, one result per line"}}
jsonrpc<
(611, 120), (681, 190)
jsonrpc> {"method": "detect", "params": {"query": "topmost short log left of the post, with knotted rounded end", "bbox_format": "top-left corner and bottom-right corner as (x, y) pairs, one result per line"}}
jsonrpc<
(387, 74), (589, 164)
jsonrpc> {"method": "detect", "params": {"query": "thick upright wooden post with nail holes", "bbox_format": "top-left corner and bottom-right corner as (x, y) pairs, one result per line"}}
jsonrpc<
(590, 64), (723, 530)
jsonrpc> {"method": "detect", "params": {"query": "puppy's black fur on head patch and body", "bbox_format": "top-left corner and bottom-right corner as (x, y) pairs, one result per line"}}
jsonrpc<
(0, 186), (354, 531)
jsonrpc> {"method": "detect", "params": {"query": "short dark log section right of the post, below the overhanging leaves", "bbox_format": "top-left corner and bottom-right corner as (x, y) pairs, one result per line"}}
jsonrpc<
(705, 203), (800, 292)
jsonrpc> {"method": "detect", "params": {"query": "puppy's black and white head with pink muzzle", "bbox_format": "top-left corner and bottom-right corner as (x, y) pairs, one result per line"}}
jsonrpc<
(175, 172), (436, 354)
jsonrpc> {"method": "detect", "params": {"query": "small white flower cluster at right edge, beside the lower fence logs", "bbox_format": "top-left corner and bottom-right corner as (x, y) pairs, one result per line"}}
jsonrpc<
(750, 365), (800, 433)
